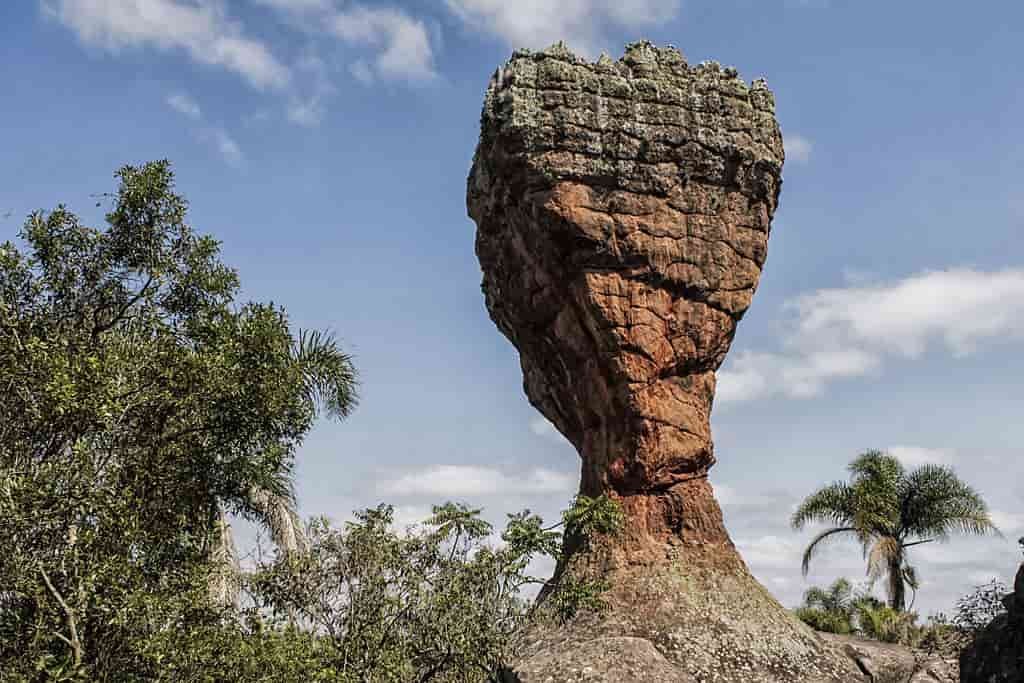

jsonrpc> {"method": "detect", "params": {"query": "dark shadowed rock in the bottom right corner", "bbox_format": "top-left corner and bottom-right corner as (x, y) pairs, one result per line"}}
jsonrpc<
(961, 565), (1024, 683)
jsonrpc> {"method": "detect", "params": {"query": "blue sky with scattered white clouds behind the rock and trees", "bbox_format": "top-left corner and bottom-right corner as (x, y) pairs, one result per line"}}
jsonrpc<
(0, 0), (1024, 612)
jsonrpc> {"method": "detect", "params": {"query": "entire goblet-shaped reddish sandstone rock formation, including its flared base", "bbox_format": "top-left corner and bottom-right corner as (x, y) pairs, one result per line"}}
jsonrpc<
(468, 43), (860, 681)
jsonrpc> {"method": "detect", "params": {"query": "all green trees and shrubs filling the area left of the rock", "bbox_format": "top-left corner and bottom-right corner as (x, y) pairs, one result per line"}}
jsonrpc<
(0, 162), (621, 682)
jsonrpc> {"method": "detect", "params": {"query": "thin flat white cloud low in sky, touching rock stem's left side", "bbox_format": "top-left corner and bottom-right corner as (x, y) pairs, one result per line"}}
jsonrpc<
(379, 465), (577, 498)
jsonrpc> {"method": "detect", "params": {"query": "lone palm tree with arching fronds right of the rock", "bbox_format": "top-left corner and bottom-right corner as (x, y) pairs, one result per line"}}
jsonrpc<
(792, 451), (999, 611)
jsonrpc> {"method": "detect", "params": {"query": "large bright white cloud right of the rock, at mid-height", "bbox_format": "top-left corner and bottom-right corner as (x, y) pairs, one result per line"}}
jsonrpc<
(718, 268), (1024, 402)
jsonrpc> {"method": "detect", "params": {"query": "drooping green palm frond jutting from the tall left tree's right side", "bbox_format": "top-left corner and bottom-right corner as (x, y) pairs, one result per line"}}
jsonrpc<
(292, 330), (358, 419)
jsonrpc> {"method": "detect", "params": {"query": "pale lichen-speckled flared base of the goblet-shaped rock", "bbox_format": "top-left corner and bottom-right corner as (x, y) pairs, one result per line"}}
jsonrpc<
(508, 548), (871, 683)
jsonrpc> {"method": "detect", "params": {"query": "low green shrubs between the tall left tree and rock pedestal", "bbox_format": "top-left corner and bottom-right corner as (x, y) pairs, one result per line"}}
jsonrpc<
(246, 497), (622, 683)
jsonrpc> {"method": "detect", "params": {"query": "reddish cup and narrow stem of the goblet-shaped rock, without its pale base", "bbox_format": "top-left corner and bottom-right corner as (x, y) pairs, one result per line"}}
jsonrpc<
(469, 44), (783, 565)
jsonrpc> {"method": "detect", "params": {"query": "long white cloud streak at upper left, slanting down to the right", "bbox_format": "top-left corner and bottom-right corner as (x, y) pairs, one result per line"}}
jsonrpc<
(43, 0), (291, 89)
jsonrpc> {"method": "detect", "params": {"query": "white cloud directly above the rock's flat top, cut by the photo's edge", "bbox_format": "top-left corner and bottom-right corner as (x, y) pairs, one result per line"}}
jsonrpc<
(446, 0), (680, 56)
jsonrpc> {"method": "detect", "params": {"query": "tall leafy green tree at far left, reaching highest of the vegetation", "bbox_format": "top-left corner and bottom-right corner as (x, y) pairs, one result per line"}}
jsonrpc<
(0, 162), (356, 680)
